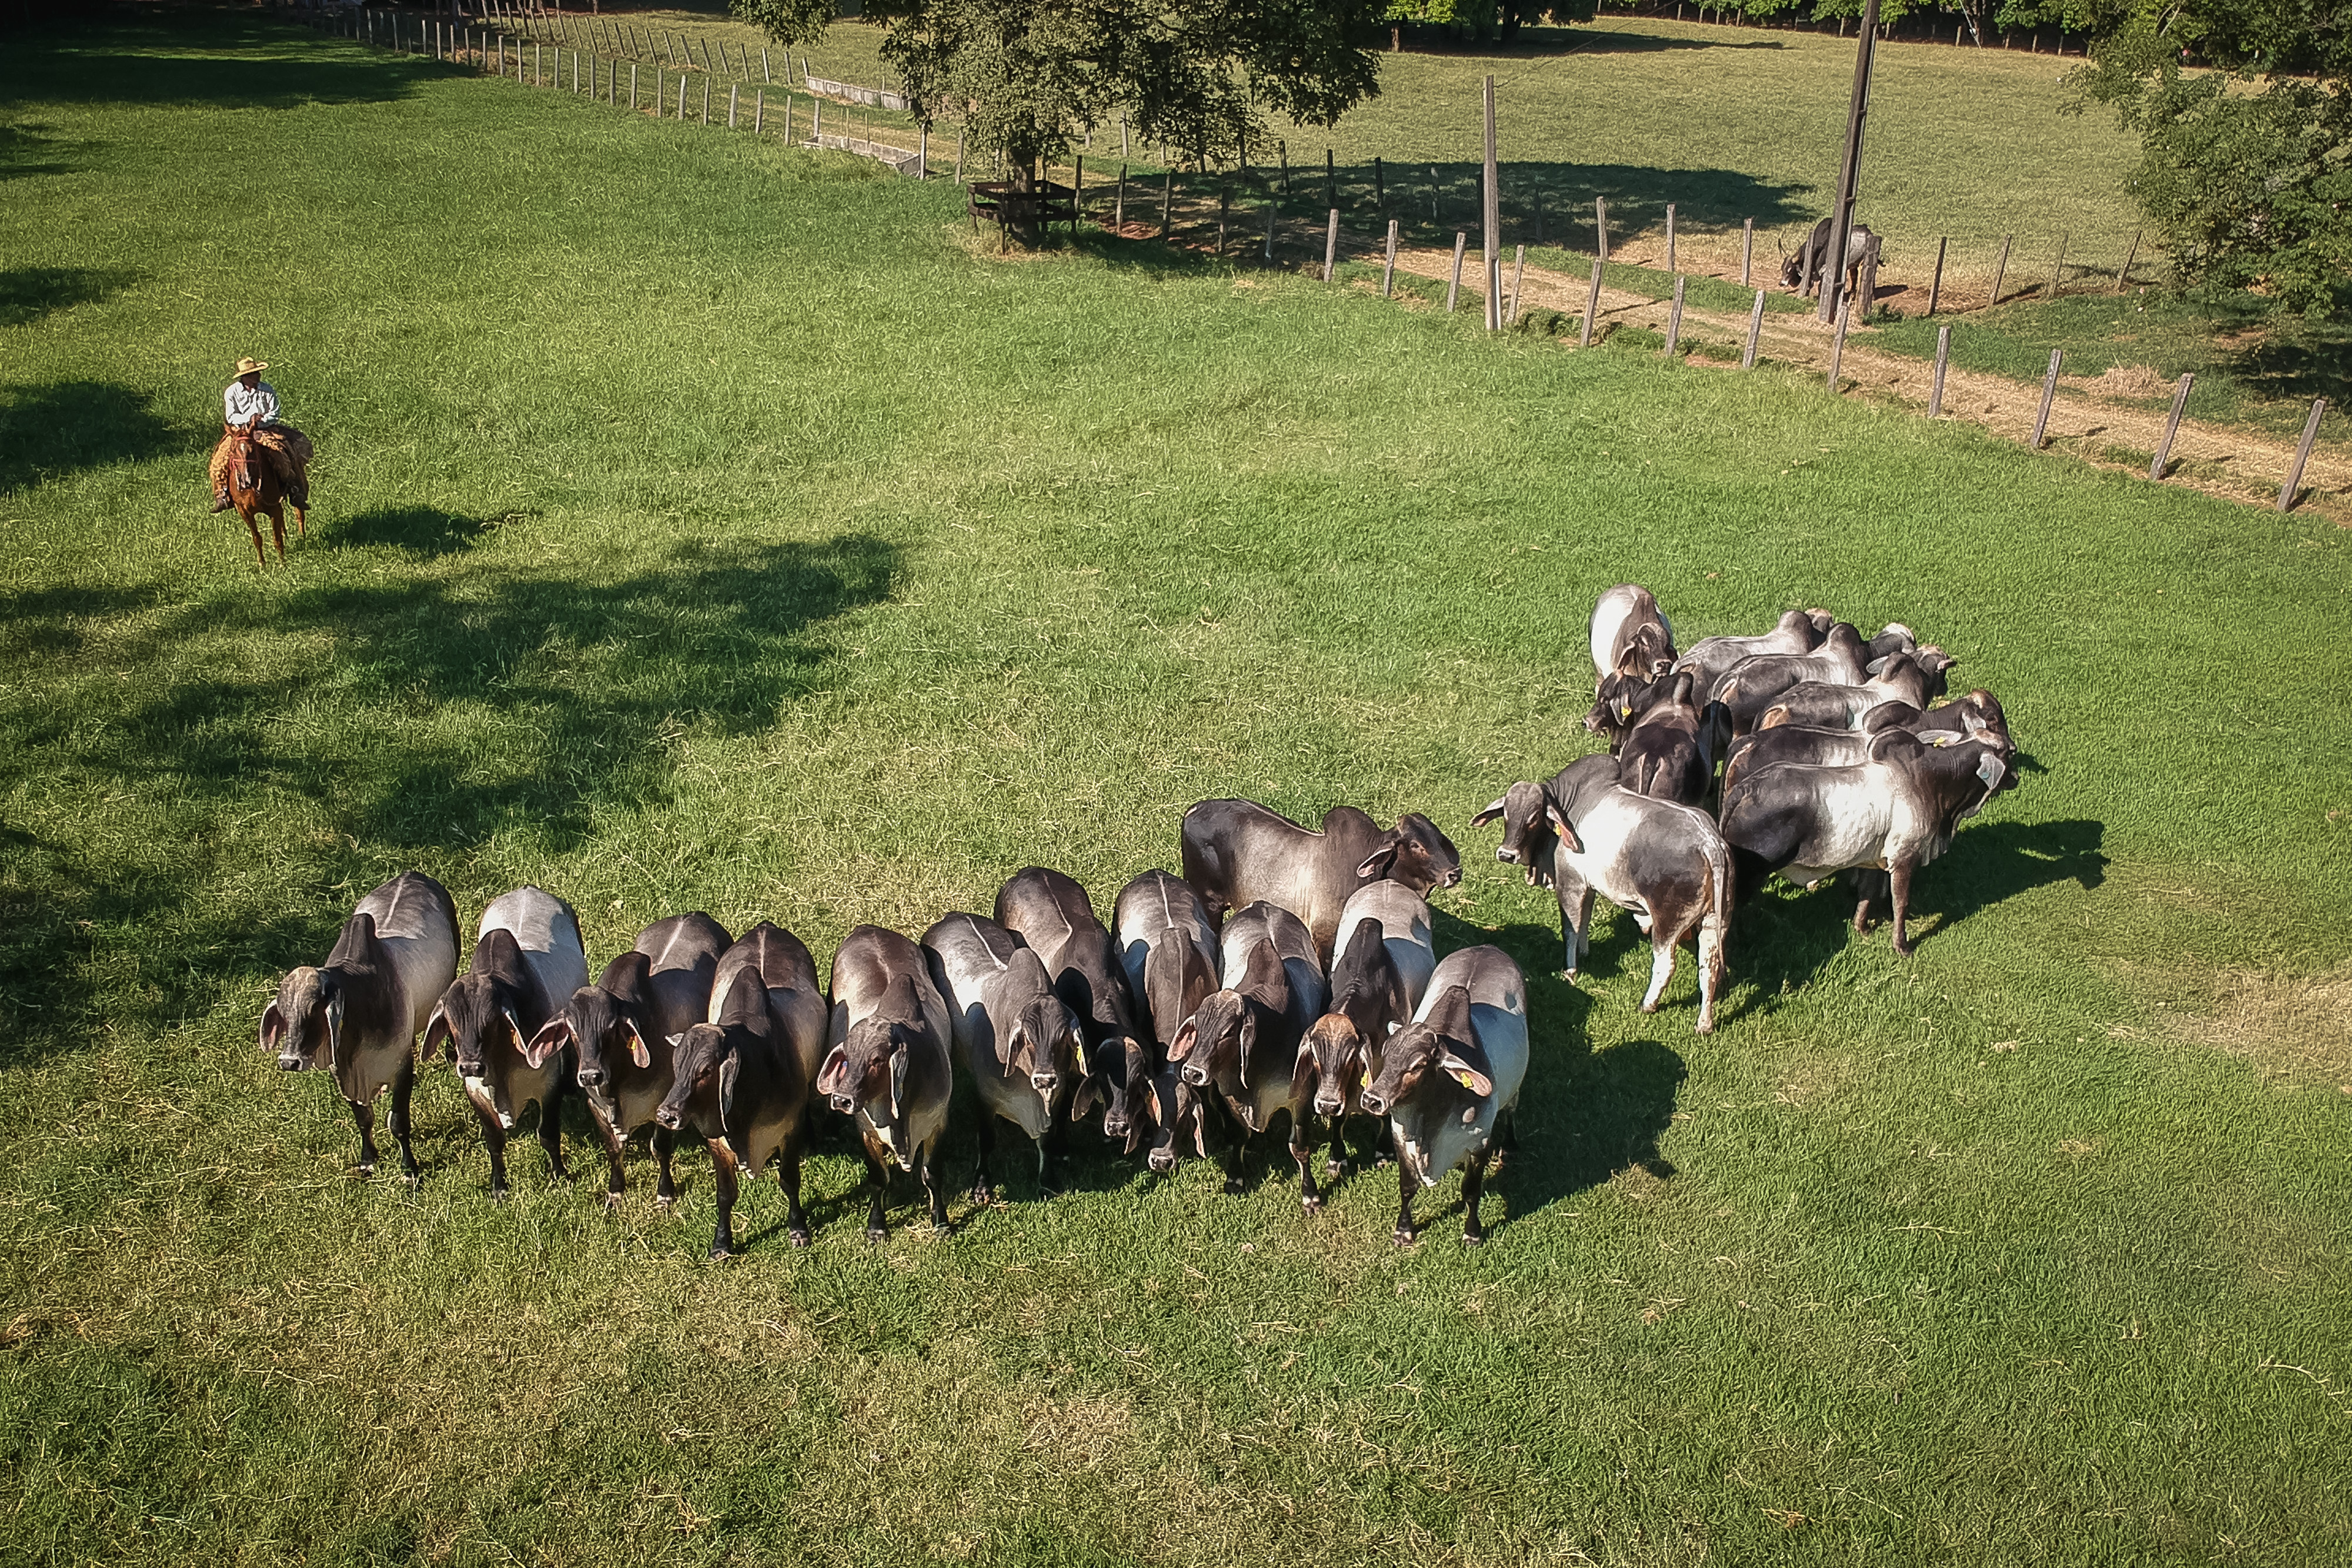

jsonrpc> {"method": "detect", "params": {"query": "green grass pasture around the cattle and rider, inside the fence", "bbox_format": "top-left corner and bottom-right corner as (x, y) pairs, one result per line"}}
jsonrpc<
(0, 14), (2352, 1566)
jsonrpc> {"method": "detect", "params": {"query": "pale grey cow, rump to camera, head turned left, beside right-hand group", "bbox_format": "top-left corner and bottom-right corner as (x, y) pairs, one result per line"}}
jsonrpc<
(1477, 757), (1733, 1034)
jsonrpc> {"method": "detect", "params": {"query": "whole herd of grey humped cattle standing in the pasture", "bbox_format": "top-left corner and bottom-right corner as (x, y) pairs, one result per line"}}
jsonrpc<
(261, 586), (2016, 1258)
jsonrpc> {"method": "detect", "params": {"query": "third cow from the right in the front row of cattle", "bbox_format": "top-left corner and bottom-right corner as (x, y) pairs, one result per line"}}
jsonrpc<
(1169, 900), (1324, 1192)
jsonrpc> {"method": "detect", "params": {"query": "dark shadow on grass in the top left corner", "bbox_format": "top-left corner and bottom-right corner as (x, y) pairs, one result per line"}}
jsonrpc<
(0, 7), (433, 112)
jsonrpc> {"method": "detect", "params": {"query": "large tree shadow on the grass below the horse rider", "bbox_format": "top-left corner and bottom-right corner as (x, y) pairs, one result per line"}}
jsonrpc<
(0, 534), (898, 1067)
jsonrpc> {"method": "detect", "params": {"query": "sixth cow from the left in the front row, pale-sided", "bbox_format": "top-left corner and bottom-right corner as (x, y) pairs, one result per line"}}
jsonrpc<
(922, 912), (1087, 1208)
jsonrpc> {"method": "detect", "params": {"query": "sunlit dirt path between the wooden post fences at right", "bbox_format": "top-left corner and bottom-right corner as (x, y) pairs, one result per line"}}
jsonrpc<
(1397, 249), (2352, 527)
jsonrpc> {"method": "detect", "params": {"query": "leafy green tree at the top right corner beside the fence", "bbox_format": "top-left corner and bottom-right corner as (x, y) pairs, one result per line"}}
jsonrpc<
(2070, 0), (2352, 317)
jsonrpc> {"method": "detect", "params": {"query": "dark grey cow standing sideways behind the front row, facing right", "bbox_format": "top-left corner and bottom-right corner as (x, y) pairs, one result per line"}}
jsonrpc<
(1183, 799), (1463, 961)
